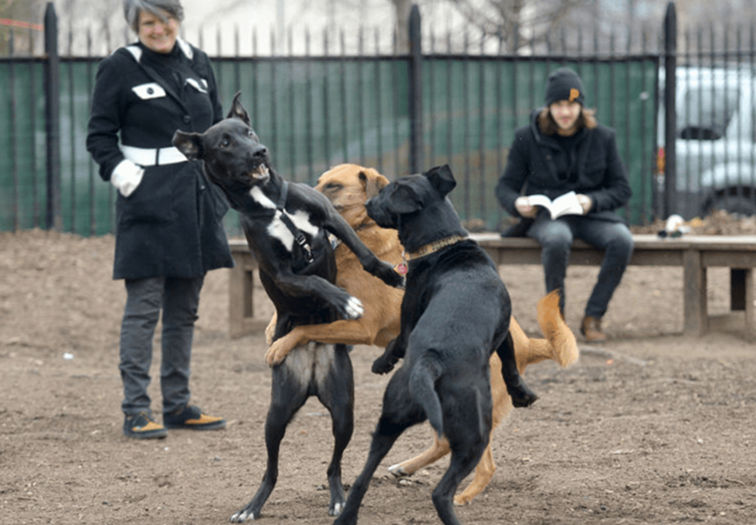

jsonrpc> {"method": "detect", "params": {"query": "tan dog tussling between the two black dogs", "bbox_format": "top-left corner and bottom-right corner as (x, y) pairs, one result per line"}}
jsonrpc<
(265, 164), (578, 505)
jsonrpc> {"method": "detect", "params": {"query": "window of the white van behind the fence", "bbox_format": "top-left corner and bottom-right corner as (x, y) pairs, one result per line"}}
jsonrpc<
(677, 87), (739, 140)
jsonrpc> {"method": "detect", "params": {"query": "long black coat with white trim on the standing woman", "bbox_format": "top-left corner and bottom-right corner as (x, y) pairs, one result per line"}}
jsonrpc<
(87, 39), (233, 279)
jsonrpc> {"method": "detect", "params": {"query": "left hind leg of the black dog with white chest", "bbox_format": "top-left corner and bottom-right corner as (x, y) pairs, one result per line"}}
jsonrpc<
(231, 349), (308, 523)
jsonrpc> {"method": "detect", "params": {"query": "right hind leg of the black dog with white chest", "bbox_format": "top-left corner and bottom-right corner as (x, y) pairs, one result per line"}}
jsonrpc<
(316, 345), (354, 516)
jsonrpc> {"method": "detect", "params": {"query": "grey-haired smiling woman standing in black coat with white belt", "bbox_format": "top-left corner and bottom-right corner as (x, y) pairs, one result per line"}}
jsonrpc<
(87, 0), (233, 438)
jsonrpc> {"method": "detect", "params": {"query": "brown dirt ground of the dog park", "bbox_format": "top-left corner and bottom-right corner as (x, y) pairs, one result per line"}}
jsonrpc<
(0, 226), (756, 525)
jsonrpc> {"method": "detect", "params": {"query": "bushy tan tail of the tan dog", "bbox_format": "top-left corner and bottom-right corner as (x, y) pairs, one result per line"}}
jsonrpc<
(513, 290), (580, 372)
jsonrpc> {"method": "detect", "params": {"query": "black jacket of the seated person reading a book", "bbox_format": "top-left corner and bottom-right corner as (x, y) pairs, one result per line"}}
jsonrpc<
(496, 109), (632, 235)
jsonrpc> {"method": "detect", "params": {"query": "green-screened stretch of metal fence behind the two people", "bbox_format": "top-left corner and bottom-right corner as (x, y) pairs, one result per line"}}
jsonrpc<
(0, 3), (672, 235)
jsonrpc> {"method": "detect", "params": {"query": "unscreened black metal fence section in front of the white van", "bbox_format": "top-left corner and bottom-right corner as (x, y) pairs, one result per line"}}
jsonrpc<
(657, 6), (756, 218)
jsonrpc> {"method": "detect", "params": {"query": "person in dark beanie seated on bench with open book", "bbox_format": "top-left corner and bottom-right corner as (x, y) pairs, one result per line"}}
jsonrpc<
(496, 68), (633, 342)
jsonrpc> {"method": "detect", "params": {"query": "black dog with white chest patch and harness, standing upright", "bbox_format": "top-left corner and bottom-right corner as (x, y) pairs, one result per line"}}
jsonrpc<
(173, 93), (403, 522)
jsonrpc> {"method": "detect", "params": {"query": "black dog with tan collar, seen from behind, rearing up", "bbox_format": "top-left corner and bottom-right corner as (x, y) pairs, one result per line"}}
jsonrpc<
(334, 166), (537, 525)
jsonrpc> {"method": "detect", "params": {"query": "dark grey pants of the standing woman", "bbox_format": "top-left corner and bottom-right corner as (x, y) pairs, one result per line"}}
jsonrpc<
(119, 276), (204, 415)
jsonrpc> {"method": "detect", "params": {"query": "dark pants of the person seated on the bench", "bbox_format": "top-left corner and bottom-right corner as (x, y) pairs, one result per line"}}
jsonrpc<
(528, 214), (633, 319)
